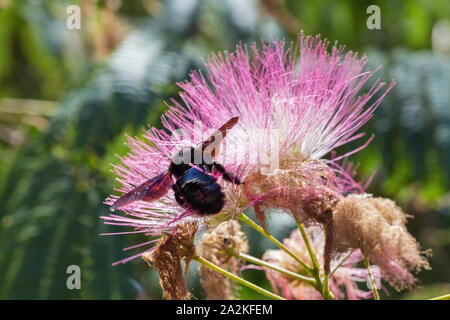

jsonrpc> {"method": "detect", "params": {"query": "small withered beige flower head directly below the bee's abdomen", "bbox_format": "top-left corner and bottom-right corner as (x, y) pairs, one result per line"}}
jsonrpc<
(197, 220), (248, 300)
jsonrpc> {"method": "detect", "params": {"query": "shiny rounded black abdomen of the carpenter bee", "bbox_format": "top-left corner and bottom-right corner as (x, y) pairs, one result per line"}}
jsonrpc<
(177, 168), (225, 214)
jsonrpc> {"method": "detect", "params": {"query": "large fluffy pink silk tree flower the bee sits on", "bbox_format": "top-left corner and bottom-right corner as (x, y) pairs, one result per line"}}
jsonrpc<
(102, 35), (393, 262)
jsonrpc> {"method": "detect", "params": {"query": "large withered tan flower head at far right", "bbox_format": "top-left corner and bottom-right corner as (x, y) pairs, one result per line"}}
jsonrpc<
(333, 195), (430, 290)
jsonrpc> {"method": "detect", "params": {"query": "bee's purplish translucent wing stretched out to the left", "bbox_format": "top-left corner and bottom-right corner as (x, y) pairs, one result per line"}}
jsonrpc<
(110, 170), (173, 211)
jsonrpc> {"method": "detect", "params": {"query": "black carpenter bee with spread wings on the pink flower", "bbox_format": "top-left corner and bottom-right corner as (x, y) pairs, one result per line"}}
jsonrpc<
(111, 117), (241, 215)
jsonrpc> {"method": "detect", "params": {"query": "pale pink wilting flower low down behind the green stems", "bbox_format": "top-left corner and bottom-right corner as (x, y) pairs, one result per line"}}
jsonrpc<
(263, 227), (372, 300)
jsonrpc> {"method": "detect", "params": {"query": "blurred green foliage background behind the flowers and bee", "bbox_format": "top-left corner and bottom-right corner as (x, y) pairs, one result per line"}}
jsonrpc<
(0, 0), (450, 299)
